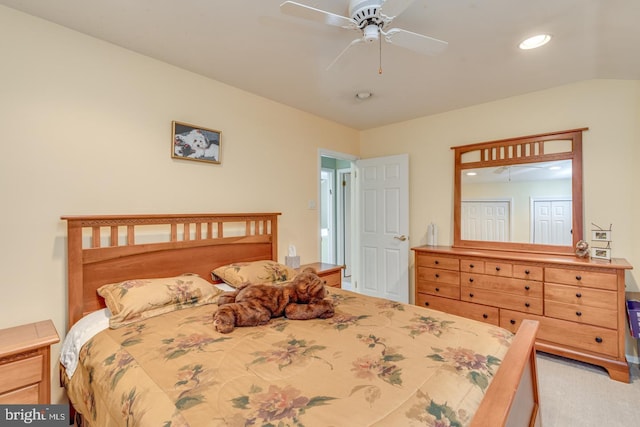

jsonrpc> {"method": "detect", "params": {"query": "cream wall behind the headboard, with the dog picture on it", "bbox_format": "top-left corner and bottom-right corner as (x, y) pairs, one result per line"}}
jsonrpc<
(0, 6), (358, 402)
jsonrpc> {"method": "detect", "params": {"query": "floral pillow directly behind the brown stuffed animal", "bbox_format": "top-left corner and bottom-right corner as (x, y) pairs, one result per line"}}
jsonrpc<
(212, 260), (298, 287)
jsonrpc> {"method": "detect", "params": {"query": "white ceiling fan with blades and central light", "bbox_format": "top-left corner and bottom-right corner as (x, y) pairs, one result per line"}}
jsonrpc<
(280, 0), (448, 73)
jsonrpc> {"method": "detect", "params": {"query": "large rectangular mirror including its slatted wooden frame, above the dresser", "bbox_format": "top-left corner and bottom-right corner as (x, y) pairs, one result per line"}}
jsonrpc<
(453, 129), (586, 254)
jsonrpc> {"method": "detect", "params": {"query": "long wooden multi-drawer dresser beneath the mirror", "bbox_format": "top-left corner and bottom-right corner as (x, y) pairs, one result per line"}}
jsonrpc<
(412, 246), (632, 382)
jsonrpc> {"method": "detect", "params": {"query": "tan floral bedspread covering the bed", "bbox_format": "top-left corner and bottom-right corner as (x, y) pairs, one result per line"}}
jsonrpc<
(66, 288), (513, 427)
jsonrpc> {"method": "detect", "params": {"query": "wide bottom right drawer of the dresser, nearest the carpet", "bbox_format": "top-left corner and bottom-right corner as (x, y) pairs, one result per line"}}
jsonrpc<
(500, 310), (618, 357)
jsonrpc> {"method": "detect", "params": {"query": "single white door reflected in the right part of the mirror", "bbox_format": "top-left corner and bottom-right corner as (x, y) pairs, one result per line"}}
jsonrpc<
(531, 199), (573, 245)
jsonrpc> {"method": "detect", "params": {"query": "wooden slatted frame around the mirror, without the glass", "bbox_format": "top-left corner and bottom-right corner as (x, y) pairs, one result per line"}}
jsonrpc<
(451, 128), (588, 255)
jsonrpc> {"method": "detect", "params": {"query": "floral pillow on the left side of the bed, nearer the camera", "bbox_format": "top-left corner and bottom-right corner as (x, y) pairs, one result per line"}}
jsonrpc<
(98, 274), (222, 329)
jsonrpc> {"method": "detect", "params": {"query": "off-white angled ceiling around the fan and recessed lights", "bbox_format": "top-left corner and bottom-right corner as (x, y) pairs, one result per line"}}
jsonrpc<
(0, 0), (640, 129)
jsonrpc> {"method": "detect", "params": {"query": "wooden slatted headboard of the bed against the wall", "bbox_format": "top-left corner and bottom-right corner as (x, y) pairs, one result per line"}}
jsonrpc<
(62, 213), (280, 327)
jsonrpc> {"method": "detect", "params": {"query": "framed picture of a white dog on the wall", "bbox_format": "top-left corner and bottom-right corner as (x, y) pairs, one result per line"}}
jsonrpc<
(171, 120), (222, 164)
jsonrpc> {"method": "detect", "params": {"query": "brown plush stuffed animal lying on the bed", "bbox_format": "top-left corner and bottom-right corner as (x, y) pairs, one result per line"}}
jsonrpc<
(213, 268), (334, 334)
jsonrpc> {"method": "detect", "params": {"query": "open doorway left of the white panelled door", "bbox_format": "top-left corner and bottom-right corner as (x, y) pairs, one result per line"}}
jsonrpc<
(319, 151), (356, 289)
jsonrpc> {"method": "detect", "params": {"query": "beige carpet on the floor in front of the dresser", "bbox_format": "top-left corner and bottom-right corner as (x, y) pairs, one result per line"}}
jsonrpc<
(537, 353), (640, 427)
